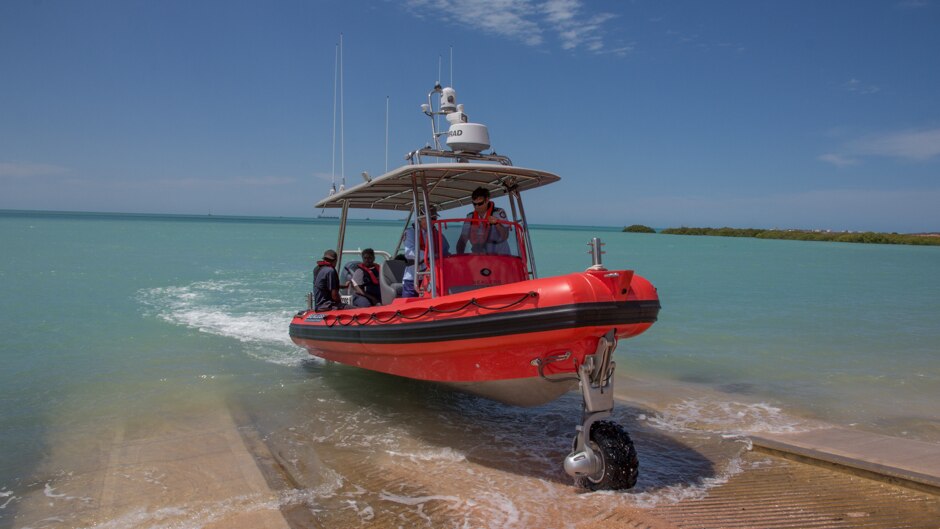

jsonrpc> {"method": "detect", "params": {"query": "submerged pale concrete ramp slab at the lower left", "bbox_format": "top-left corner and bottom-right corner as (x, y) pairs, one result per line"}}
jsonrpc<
(8, 411), (291, 529)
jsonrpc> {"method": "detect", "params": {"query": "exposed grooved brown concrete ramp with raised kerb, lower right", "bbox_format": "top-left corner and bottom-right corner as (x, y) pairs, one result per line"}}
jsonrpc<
(578, 428), (940, 529)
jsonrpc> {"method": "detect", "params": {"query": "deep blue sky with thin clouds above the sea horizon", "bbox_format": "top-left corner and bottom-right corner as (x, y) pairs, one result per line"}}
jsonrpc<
(0, 0), (940, 232)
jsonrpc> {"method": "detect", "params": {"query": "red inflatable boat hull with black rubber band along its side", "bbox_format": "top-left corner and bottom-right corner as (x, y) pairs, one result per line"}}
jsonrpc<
(290, 271), (659, 405)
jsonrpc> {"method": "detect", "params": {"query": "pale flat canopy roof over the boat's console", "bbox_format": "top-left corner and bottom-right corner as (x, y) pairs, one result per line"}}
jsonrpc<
(316, 163), (561, 211)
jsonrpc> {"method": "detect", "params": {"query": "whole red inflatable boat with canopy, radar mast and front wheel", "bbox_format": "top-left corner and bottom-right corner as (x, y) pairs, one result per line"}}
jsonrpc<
(290, 86), (660, 488)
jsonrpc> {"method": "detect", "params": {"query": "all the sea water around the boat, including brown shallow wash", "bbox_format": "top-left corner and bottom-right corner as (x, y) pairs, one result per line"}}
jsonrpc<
(0, 214), (940, 527)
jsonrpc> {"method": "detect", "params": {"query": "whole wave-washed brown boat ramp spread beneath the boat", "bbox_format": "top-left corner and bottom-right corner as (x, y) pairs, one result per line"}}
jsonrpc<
(12, 365), (940, 529)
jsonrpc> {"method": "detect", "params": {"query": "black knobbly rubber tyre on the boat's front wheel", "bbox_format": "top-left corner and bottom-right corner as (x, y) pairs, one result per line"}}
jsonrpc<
(578, 421), (640, 490)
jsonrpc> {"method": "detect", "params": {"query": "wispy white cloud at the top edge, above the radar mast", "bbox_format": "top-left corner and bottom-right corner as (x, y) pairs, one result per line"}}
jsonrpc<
(405, 0), (620, 55)
